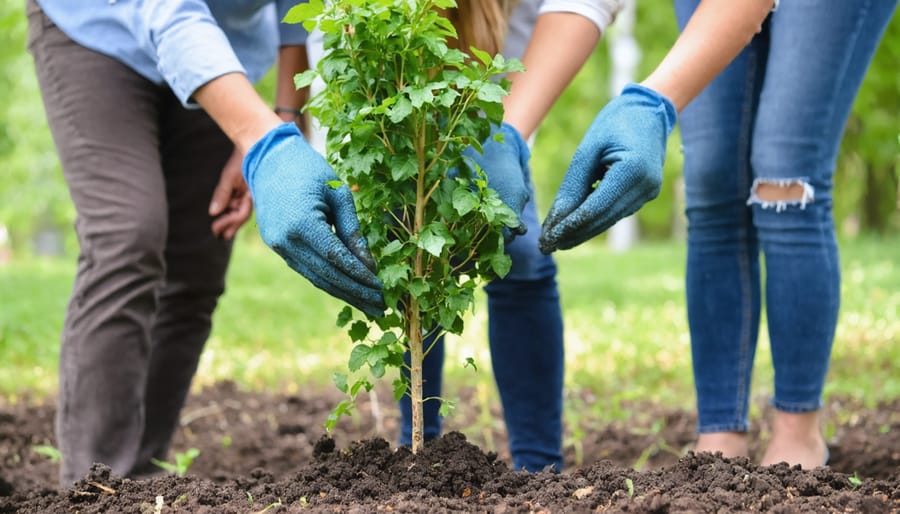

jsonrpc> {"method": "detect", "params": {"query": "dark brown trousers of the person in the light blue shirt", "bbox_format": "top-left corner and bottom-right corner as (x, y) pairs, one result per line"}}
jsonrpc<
(27, 0), (233, 486)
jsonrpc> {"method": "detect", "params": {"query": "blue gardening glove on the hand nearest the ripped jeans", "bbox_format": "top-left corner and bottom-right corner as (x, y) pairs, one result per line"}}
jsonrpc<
(539, 84), (676, 254)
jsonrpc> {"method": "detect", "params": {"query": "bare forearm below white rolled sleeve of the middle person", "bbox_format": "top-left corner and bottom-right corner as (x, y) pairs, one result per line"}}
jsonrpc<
(503, 13), (600, 139)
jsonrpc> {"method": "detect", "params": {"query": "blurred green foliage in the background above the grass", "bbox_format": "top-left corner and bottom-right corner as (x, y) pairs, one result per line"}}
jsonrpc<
(0, 0), (900, 254)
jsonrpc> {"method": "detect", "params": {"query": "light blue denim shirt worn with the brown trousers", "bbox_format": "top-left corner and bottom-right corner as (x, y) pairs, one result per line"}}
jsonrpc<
(37, 0), (306, 105)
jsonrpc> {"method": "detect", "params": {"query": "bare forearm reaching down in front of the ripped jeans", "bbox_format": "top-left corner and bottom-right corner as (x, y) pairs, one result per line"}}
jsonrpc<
(642, 0), (773, 111)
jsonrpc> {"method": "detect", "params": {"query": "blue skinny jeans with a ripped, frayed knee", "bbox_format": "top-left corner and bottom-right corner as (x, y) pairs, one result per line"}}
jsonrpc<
(675, 0), (897, 433)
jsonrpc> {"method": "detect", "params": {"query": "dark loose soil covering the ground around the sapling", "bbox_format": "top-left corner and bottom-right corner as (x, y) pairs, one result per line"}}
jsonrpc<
(0, 383), (900, 514)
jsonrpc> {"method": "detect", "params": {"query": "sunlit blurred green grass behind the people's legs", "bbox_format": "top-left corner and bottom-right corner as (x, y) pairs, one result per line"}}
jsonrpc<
(0, 235), (900, 419)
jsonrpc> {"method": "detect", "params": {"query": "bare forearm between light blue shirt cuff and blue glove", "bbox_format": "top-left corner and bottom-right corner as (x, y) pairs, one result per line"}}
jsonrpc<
(193, 73), (282, 154)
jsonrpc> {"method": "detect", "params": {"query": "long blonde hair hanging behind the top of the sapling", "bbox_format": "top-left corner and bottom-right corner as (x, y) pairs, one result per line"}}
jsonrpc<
(447, 0), (518, 55)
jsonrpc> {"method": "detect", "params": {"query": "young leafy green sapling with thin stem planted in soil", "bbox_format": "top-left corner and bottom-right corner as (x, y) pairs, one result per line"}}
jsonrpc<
(285, 0), (523, 452)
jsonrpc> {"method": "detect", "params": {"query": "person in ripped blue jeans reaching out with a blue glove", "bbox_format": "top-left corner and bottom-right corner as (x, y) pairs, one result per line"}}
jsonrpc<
(532, 0), (897, 468)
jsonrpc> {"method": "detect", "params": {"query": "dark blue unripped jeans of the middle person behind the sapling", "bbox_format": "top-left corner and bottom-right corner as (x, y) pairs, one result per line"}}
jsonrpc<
(400, 173), (564, 471)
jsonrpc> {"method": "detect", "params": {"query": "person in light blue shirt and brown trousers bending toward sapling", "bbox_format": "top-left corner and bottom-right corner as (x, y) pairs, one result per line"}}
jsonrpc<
(27, 0), (342, 485)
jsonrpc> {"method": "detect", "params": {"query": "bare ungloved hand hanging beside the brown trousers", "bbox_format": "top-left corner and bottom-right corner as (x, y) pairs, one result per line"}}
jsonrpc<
(209, 149), (253, 240)
